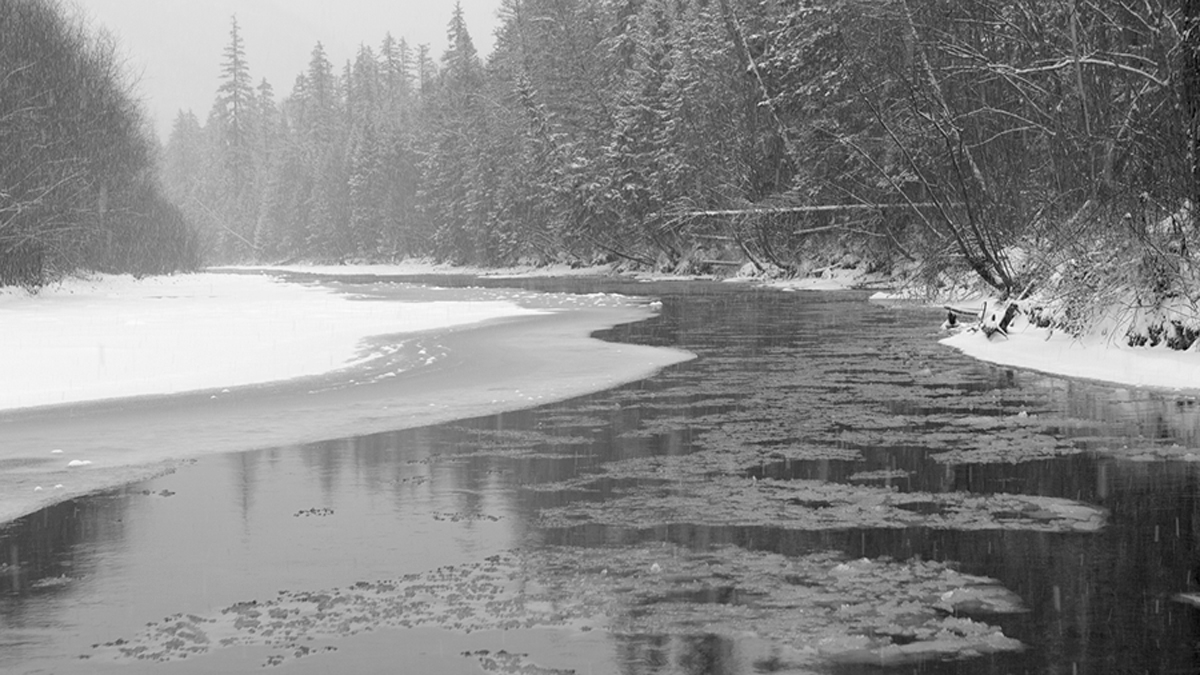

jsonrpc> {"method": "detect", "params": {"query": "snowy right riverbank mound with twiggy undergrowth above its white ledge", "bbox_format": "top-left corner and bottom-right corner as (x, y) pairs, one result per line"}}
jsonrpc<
(943, 229), (1200, 390)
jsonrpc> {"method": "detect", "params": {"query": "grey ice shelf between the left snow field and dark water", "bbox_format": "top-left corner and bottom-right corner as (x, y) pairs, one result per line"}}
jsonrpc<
(0, 270), (694, 524)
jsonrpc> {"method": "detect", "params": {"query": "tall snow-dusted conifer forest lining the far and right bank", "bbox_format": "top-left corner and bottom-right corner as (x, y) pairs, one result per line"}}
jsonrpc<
(174, 0), (1200, 302)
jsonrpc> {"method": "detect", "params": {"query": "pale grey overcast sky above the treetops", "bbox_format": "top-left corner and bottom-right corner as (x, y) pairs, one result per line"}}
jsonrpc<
(71, 0), (500, 141)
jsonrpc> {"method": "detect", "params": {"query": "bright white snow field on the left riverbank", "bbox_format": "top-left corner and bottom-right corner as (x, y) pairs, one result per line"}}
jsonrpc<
(0, 269), (540, 410)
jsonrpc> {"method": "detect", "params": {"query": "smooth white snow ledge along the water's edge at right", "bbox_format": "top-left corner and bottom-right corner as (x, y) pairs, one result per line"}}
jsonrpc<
(942, 322), (1200, 390)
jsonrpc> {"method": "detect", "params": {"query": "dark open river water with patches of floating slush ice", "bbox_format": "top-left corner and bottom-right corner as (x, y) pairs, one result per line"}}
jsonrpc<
(0, 277), (1200, 674)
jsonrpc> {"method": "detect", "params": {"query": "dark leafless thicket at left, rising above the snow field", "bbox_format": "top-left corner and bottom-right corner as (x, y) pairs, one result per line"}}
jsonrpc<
(0, 0), (199, 288)
